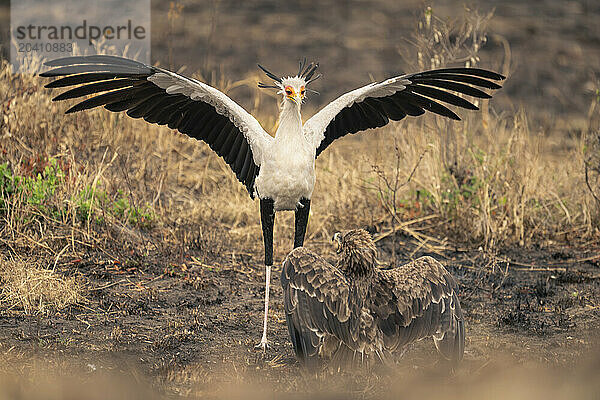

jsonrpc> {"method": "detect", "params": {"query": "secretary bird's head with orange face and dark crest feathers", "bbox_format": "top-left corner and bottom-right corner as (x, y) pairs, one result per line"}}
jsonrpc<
(258, 59), (321, 106)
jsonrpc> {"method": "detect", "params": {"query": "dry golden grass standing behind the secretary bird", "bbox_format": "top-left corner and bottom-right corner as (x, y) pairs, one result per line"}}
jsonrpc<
(0, 6), (598, 314)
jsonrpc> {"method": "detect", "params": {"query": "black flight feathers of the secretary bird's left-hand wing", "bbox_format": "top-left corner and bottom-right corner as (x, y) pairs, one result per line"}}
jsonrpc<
(40, 55), (259, 197)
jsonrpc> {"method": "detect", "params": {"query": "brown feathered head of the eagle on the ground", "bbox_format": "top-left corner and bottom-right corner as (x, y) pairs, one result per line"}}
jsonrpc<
(333, 229), (377, 276)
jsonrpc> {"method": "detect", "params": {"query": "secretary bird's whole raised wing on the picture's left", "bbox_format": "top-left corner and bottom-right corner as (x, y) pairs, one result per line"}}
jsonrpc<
(40, 55), (272, 197)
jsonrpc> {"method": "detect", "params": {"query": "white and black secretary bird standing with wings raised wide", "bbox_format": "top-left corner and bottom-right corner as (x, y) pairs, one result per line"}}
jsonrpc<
(40, 55), (504, 350)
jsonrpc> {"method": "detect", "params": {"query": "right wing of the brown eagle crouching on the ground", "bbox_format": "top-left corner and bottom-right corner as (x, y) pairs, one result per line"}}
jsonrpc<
(371, 257), (465, 361)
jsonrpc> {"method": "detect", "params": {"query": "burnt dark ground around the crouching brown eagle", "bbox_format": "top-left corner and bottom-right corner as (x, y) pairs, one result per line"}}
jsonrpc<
(0, 227), (600, 393)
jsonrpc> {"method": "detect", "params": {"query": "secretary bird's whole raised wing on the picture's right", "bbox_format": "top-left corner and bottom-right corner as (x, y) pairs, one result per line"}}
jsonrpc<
(304, 68), (504, 157)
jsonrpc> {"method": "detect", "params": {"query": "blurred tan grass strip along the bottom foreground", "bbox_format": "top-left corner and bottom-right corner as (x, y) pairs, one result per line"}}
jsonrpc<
(0, 354), (600, 400)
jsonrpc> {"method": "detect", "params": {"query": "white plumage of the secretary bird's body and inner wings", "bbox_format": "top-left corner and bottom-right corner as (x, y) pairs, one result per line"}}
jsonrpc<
(148, 70), (409, 211)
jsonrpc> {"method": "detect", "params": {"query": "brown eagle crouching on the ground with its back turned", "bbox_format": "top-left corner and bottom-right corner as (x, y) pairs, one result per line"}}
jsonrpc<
(281, 229), (465, 369)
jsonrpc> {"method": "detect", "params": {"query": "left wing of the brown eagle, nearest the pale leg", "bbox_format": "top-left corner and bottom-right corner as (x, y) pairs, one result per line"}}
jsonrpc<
(281, 247), (360, 363)
